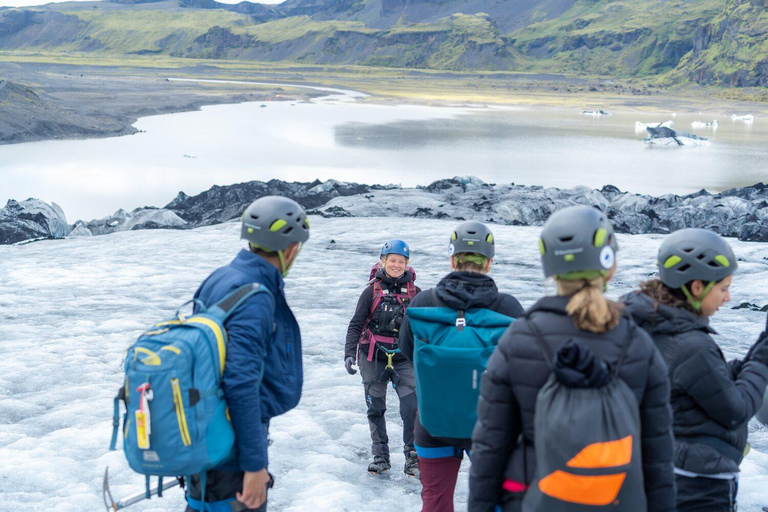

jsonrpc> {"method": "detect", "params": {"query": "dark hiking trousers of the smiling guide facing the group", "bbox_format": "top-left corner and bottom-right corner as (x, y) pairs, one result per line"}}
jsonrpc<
(359, 353), (418, 460)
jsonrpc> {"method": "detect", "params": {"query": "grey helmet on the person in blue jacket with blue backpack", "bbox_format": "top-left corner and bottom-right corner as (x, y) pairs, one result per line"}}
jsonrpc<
(240, 196), (309, 251)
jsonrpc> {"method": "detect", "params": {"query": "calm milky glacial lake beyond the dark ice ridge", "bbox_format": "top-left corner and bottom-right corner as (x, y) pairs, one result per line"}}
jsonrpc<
(0, 86), (768, 222)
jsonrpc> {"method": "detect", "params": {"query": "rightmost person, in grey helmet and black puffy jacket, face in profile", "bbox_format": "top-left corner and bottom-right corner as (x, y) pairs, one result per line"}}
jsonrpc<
(624, 229), (768, 512)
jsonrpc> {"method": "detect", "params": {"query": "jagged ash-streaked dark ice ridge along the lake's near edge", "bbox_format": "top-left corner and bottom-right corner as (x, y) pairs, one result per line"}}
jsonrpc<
(0, 177), (768, 244)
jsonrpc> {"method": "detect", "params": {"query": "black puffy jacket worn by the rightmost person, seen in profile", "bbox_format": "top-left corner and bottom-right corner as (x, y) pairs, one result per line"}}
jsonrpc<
(622, 292), (768, 474)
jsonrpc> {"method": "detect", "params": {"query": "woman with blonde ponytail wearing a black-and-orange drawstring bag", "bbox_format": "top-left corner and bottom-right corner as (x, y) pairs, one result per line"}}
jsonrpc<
(469, 206), (675, 512)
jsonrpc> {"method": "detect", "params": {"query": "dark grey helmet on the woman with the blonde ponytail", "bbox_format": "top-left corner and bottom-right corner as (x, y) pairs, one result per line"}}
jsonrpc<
(539, 206), (619, 279)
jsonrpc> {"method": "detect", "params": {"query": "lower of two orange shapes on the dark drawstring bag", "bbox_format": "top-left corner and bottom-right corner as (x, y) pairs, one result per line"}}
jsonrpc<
(539, 470), (627, 506)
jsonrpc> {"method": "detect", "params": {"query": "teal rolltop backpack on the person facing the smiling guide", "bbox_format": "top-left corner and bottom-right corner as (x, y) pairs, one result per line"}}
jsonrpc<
(405, 288), (514, 439)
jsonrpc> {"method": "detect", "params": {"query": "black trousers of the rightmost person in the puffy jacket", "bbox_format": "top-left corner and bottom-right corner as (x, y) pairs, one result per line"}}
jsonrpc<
(675, 475), (739, 512)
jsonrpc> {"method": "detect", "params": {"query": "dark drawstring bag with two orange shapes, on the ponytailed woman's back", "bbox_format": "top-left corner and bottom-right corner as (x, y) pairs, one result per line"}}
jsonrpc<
(522, 319), (647, 512)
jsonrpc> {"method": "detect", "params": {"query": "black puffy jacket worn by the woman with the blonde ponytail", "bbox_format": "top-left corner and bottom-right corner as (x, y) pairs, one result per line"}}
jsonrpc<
(469, 297), (675, 512)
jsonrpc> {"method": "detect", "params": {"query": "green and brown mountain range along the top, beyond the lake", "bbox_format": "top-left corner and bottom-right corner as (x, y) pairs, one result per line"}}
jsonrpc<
(0, 0), (768, 86)
